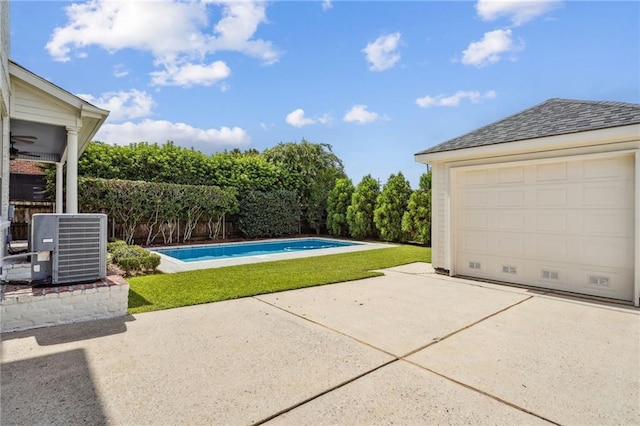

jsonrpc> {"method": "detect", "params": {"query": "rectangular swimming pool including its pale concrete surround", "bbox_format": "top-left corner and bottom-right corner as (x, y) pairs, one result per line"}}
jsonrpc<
(149, 237), (393, 273)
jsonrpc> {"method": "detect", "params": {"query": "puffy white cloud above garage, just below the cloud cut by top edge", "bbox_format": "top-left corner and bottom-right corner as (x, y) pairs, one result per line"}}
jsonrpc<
(462, 29), (524, 67)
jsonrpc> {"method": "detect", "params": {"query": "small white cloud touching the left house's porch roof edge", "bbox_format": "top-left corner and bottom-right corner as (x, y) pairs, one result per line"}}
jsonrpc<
(78, 89), (154, 122)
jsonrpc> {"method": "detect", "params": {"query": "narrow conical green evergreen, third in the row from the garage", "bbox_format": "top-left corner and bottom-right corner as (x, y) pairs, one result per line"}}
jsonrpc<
(347, 175), (380, 239)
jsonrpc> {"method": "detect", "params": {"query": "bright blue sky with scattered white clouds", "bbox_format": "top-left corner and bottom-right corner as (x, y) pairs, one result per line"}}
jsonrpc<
(10, 0), (640, 188)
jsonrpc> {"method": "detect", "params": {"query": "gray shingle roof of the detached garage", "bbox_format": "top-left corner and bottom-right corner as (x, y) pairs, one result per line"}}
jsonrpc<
(417, 98), (640, 155)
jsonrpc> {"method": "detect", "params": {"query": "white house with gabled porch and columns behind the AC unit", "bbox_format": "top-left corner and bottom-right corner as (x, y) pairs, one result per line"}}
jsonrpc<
(0, 1), (109, 267)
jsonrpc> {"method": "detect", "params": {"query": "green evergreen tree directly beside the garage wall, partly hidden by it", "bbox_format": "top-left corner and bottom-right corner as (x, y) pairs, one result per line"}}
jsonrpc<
(402, 171), (431, 245)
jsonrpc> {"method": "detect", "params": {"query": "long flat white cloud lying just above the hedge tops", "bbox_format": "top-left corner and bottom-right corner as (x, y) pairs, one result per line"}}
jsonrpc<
(95, 119), (251, 152)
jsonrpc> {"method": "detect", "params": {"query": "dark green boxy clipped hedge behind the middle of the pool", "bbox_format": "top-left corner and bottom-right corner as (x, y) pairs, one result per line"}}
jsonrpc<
(238, 190), (300, 238)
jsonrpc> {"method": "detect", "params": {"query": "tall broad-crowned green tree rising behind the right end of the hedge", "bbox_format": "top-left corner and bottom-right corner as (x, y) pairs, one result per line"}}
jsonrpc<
(262, 139), (346, 232)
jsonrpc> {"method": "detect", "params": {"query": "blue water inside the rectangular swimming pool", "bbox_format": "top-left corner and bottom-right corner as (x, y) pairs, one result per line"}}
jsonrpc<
(154, 238), (360, 262)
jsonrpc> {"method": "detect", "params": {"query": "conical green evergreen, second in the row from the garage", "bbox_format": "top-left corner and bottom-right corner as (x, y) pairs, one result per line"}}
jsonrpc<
(373, 172), (411, 241)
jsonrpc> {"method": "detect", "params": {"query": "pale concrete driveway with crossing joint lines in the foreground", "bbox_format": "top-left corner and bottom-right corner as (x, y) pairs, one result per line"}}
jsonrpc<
(0, 264), (640, 425)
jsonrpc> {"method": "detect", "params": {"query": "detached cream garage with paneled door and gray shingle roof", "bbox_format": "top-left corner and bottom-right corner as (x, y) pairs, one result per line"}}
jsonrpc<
(415, 99), (640, 306)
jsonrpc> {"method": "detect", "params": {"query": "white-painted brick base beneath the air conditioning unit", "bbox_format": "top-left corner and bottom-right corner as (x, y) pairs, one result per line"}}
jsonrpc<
(0, 275), (129, 333)
